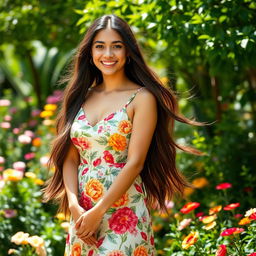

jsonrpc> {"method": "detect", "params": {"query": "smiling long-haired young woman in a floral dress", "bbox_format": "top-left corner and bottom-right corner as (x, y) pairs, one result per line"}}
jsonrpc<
(43, 14), (210, 256)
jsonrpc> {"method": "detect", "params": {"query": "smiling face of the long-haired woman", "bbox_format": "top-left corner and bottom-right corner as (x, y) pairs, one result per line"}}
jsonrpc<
(92, 28), (126, 75)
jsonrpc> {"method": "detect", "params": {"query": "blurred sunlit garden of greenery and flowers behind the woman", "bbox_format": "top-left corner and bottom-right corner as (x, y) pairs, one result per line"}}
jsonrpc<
(0, 0), (256, 256)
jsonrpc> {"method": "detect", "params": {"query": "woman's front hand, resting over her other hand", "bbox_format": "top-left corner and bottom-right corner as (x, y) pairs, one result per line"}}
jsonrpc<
(75, 207), (103, 240)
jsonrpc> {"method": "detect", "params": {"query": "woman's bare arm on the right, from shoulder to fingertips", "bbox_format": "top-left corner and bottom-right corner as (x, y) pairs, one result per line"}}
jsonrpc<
(75, 90), (157, 238)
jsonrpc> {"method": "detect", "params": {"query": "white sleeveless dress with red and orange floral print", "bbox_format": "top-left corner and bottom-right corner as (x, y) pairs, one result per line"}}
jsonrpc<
(64, 87), (156, 256)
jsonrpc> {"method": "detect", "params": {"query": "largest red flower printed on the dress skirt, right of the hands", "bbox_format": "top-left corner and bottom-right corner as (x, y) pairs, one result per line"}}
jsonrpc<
(108, 207), (138, 234)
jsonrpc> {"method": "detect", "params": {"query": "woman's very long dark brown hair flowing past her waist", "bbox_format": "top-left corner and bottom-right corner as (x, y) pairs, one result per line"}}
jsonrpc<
(42, 14), (214, 215)
